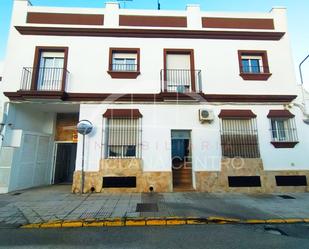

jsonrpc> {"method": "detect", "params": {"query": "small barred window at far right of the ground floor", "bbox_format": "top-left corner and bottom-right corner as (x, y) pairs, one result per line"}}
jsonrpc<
(270, 118), (298, 142)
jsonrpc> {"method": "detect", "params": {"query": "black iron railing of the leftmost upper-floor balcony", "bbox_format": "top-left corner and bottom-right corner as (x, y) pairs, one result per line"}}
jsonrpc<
(20, 67), (69, 91)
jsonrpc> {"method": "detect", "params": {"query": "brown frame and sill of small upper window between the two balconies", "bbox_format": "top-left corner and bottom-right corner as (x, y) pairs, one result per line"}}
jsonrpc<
(107, 48), (141, 79)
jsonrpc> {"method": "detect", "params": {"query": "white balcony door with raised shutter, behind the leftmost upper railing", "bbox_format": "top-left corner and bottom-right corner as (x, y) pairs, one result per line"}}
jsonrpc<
(37, 52), (64, 91)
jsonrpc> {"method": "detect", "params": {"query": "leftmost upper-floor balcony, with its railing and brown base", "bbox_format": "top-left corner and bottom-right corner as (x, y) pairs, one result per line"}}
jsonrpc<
(19, 67), (69, 99)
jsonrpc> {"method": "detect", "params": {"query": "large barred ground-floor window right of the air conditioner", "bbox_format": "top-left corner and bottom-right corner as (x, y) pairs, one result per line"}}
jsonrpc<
(221, 118), (260, 158)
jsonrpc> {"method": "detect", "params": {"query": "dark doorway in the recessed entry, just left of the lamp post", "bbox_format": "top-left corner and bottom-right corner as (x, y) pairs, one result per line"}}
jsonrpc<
(54, 143), (77, 184)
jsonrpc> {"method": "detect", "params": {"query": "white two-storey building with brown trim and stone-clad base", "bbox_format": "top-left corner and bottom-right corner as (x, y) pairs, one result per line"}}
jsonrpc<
(0, 0), (309, 192)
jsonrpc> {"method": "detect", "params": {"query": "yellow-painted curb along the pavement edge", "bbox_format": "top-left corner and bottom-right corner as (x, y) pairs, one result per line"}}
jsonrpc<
(20, 216), (309, 229)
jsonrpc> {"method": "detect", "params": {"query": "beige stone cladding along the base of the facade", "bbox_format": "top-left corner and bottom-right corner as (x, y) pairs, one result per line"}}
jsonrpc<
(72, 158), (309, 193)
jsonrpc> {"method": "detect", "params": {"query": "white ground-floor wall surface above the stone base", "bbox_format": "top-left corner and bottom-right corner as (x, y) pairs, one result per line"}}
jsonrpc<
(77, 104), (309, 175)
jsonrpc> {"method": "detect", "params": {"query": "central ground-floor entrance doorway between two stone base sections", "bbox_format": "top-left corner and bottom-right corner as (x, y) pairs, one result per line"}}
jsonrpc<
(172, 130), (192, 190)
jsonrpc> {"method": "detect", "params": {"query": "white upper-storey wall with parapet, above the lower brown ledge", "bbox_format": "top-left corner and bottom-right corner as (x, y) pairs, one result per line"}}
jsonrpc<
(3, 1), (298, 97)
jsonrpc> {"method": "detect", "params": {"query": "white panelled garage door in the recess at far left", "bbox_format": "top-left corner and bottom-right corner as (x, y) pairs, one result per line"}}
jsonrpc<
(9, 133), (52, 191)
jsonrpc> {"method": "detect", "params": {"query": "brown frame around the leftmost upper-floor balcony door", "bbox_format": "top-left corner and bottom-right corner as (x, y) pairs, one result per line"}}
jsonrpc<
(31, 46), (69, 92)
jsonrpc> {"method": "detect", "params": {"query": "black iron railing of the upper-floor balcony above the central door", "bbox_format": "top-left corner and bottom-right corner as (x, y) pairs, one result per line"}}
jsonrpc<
(160, 69), (202, 94)
